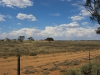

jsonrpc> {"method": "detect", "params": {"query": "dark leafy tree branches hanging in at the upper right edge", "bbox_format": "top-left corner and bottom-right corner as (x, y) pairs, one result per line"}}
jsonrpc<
(83, 0), (100, 34)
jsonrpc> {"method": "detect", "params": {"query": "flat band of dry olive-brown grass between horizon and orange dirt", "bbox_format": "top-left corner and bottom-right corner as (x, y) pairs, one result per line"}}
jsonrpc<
(0, 41), (100, 56)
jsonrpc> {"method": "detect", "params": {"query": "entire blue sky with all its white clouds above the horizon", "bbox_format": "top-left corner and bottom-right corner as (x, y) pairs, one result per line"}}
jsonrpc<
(0, 0), (100, 40)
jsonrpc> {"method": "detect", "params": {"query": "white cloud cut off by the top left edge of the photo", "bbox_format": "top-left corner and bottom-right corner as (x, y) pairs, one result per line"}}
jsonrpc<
(0, 0), (33, 8)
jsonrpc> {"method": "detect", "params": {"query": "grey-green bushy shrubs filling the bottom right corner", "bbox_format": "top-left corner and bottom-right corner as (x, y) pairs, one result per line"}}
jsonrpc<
(63, 61), (100, 75)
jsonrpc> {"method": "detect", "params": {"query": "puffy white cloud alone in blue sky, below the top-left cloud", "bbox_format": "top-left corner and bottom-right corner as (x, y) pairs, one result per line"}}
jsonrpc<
(16, 13), (37, 21)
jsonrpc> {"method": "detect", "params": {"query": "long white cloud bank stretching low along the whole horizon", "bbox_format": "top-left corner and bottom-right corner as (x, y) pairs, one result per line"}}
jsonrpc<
(0, 22), (99, 40)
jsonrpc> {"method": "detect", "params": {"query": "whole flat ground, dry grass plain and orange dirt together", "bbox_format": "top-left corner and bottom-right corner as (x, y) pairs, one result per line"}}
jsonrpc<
(0, 41), (100, 75)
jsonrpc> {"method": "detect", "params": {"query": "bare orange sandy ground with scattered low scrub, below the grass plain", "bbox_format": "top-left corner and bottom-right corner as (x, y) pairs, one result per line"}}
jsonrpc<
(0, 50), (100, 75)
